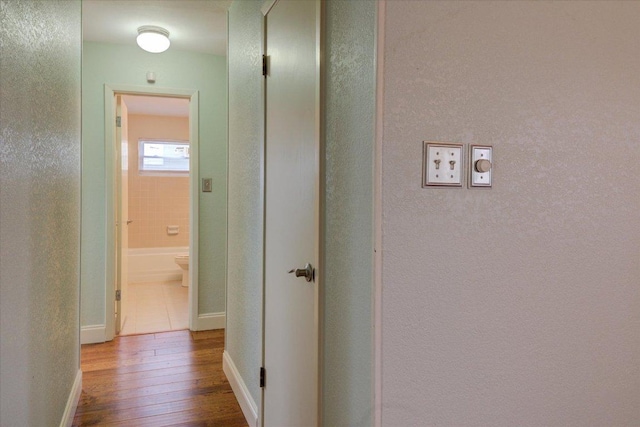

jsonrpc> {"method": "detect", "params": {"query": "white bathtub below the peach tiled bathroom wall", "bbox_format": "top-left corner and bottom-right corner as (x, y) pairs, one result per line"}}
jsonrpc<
(127, 246), (189, 283)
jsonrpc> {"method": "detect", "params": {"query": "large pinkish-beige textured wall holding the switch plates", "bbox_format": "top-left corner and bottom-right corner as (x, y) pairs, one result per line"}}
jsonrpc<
(382, 1), (640, 426)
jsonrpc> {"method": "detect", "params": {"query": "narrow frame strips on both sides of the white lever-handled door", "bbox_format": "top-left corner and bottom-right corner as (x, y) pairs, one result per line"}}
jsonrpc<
(257, 0), (325, 426)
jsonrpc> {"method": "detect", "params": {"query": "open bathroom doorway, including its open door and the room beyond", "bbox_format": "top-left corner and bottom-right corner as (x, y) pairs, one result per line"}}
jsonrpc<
(105, 87), (198, 342)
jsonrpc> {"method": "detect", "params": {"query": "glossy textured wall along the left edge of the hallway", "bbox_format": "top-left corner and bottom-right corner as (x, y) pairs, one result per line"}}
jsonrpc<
(0, 0), (81, 427)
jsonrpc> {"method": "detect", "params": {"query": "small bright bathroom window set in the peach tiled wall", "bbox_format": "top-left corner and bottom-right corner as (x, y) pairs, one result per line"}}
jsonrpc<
(138, 139), (189, 175)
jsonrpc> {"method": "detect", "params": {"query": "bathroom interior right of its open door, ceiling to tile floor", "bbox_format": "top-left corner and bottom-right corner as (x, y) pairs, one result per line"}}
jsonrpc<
(120, 95), (190, 335)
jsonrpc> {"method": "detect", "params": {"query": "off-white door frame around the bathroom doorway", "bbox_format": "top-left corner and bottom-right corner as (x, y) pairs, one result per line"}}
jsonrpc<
(104, 84), (200, 341)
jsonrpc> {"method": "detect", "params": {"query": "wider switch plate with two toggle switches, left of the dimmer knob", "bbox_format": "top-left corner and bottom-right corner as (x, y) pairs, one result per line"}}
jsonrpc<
(422, 141), (464, 187)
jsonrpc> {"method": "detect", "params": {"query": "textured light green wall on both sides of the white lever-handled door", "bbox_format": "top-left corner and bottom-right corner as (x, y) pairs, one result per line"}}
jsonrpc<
(226, 0), (376, 426)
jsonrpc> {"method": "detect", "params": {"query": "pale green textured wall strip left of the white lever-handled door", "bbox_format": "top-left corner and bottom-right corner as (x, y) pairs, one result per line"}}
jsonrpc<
(225, 0), (264, 405)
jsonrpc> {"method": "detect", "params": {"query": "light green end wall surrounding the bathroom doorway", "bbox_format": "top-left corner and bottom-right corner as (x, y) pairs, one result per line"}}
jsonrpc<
(81, 42), (227, 326)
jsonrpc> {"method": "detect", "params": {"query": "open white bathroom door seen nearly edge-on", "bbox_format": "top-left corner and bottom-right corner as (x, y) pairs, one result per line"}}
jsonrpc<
(115, 95), (130, 334)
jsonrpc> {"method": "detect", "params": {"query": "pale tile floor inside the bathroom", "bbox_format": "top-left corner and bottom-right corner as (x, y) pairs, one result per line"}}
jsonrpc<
(120, 282), (189, 335)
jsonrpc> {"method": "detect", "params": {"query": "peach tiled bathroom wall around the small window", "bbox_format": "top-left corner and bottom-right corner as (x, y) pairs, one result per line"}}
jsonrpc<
(127, 114), (190, 248)
